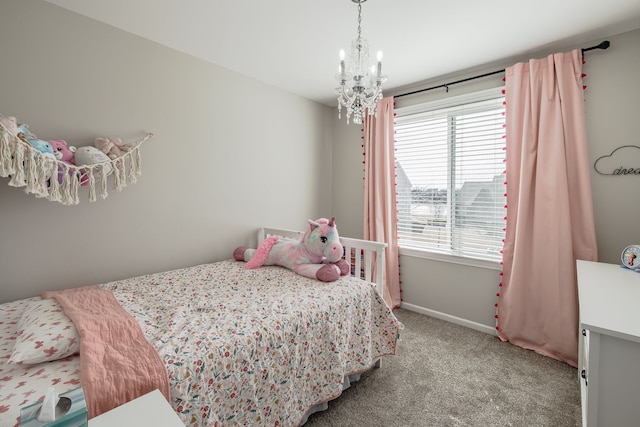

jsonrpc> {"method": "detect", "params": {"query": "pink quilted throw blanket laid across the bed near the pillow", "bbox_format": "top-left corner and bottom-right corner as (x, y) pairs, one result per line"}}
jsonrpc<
(41, 286), (170, 418)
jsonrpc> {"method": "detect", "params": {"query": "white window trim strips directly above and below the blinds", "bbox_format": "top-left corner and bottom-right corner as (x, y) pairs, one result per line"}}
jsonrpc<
(395, 87), (506, 271)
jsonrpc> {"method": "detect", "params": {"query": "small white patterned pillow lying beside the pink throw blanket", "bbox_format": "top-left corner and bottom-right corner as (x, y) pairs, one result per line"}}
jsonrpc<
(9, 298), (80, 365)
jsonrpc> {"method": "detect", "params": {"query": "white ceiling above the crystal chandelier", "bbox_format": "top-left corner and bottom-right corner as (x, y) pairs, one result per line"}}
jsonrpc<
(46, 0), (640, 106)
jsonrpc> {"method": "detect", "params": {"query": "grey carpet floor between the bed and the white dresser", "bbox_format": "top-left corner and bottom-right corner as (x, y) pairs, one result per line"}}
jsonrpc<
(305, 309), (581, 427)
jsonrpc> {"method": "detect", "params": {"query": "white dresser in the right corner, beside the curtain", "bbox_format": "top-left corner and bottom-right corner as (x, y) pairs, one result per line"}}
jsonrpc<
(577, 260), (640, 427)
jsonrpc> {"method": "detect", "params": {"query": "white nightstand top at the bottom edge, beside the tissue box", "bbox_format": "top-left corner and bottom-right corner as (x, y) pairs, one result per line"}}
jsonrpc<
(89, 390), (184, 427)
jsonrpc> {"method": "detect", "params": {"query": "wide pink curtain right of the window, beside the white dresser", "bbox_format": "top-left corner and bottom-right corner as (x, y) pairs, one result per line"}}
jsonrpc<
(496, 50), (597, 366)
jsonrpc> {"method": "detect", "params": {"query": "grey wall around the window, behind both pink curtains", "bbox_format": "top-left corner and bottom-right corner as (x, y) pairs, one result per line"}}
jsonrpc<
(333, 30), (640, 333)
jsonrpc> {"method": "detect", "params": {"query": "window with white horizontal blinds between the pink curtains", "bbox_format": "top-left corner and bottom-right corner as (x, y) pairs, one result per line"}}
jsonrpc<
(395, 90), (506, 261)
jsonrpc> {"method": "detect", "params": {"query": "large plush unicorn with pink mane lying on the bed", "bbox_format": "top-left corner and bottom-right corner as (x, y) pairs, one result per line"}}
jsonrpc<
(233, 218), (350, 282)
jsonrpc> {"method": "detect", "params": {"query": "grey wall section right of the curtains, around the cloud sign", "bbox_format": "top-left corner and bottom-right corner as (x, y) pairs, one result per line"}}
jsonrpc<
(584, 30), (640, 264)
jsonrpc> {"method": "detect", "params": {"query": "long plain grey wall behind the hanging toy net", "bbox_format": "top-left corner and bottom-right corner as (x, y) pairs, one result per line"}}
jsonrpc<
(0, 0), (333, 302)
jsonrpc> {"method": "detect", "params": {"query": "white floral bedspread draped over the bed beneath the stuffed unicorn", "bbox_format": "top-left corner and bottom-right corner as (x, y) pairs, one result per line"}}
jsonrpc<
(0, 260), (399, 427)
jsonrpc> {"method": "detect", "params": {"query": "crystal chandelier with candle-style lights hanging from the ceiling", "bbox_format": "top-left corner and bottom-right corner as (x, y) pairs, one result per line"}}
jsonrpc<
(336, 0), (387, 124)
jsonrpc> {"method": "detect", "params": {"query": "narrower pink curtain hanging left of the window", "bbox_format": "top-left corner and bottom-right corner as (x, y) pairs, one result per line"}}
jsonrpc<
(364, 97), (401, 308)
